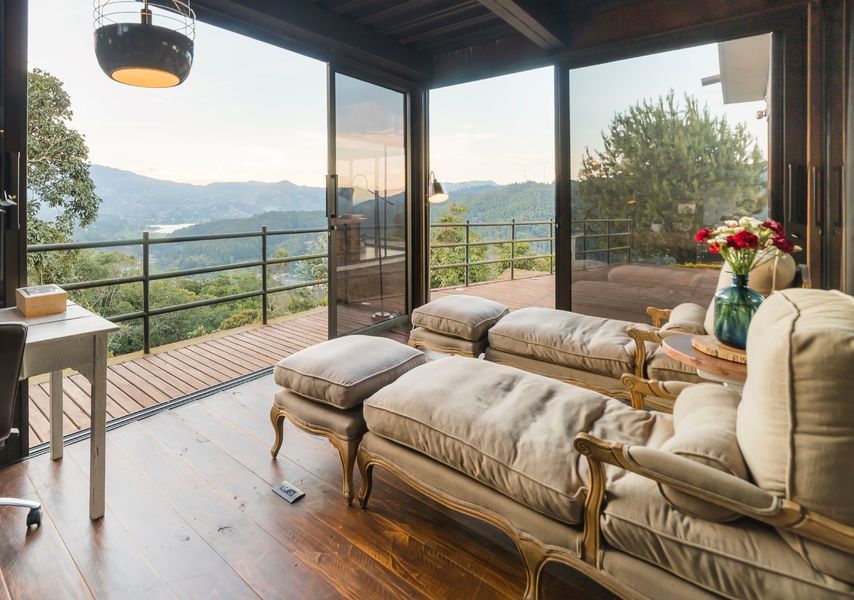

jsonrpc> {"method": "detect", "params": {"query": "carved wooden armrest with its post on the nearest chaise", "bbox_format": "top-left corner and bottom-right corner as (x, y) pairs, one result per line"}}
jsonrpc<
(574, 433), (854, 564)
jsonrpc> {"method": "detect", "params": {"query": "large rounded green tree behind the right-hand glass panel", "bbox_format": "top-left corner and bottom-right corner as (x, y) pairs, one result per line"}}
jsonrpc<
(578, 90), (767, 262)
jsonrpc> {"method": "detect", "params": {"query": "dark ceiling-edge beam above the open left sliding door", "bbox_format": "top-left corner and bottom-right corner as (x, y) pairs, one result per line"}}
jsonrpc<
(193, 0), (432, 80)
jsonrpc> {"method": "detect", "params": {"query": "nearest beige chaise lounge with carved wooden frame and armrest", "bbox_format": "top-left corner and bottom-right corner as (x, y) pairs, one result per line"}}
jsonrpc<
(357, 290), (854, 598)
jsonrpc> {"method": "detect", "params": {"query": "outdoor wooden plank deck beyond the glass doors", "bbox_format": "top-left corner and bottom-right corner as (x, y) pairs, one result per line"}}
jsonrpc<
(29, 271), (717, 447)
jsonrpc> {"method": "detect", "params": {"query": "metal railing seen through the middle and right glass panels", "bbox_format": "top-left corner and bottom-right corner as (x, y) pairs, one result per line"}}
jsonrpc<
(430, 219), (632, 285)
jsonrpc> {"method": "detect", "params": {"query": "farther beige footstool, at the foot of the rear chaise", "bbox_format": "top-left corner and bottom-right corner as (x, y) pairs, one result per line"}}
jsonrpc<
(409, 294), (510, 358)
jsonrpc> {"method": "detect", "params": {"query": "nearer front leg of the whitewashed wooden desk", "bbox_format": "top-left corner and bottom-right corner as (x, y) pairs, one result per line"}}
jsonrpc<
(89, 335), (107, 521)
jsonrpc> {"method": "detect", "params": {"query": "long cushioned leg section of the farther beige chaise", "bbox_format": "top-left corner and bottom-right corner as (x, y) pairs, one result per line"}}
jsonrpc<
(486, 308), (652, 394)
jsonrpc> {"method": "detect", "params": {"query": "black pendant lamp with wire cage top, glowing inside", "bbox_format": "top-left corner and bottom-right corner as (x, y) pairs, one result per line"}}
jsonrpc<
(95, 0), (195, 88)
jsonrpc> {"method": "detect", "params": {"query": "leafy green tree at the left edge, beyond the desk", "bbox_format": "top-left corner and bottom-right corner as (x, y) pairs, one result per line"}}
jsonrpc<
(27, 69), (101, 283)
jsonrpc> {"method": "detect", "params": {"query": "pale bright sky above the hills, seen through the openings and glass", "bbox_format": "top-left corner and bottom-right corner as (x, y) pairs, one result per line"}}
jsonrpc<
(29, 0), (767, 186)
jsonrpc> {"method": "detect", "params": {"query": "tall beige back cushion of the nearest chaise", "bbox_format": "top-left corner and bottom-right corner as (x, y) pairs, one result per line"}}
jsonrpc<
(737, 289), (854, 582)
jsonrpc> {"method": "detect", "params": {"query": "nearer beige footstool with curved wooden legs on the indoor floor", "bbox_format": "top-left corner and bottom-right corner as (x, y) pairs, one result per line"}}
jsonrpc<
(270, 335), (427, 505)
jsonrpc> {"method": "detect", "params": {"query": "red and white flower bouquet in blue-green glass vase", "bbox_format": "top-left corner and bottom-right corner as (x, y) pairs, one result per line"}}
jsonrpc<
(695, 217), (800, 349)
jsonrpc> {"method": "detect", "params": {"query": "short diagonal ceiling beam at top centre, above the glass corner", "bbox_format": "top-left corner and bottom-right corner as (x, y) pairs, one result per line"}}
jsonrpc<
(478, 0), (569, 52)
